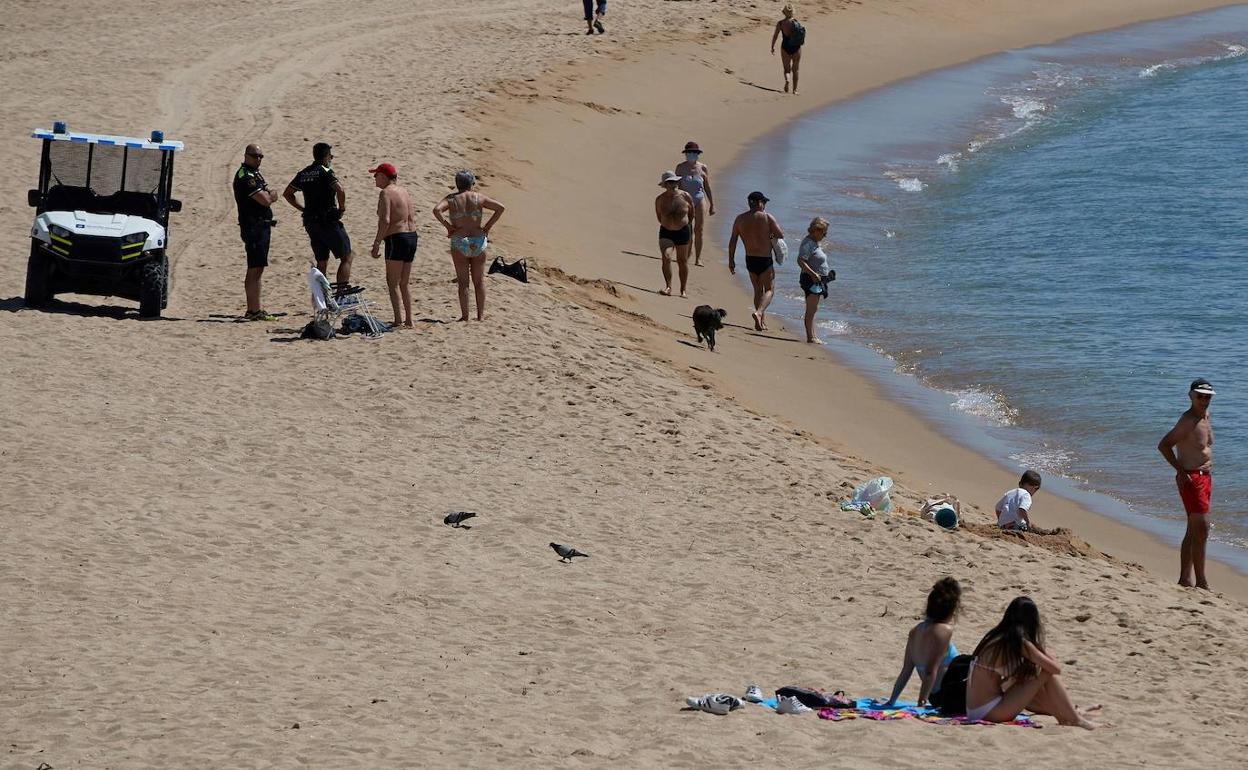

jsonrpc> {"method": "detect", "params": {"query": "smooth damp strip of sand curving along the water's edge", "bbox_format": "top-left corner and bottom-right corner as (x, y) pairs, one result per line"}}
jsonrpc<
(490, 1), (1248, 599)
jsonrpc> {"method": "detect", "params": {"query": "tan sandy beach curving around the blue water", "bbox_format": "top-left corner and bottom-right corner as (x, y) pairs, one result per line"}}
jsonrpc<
(0, 0), (1248, 770)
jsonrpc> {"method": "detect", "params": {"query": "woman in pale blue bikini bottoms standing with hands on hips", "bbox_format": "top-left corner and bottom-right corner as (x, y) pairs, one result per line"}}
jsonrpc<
(433, 171), (503, 321)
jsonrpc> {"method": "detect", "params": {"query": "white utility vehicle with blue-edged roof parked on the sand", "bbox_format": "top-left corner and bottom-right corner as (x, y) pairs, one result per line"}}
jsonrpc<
(26, 121), (182, 318)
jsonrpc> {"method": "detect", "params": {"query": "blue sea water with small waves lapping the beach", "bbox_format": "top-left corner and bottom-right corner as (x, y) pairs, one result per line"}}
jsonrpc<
(723, 6), (1248, 569)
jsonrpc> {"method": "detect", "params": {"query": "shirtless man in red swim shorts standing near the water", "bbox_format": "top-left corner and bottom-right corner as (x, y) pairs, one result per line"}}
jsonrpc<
(1157, 378), (1213, 590)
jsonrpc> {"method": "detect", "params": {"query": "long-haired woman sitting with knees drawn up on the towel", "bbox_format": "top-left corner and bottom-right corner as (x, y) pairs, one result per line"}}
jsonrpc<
(966, 597), (1101, 730)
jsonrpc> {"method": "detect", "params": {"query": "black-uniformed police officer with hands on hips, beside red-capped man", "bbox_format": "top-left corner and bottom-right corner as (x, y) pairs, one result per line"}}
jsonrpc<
(282, 142), (352, 283)
